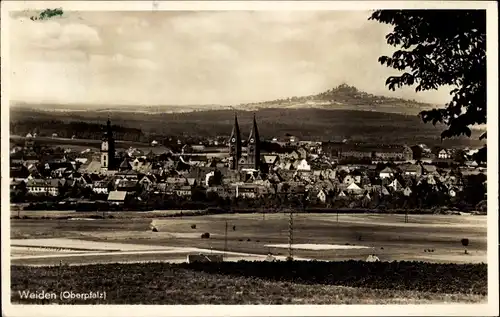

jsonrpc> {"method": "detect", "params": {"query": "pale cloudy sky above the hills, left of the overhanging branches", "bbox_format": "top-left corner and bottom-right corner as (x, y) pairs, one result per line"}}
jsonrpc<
(10, 11), (449, 105)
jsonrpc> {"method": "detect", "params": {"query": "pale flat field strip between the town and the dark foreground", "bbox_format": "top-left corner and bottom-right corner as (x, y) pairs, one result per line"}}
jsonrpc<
(11, 211), (487, 265)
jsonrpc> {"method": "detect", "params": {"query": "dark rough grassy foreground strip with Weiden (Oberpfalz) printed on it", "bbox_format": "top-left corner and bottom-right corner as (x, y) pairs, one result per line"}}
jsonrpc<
(11, 261), (487, 305)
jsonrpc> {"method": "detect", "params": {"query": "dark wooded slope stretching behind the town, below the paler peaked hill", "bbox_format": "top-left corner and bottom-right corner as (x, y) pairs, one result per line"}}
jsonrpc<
(6, 108), (480, 146)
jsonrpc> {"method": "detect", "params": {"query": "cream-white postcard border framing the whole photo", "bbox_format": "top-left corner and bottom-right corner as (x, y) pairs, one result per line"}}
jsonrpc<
(1, 1), (499, 317)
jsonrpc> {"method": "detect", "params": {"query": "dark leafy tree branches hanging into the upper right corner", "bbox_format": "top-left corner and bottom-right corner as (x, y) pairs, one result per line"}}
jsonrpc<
(369, 10), (486, 139)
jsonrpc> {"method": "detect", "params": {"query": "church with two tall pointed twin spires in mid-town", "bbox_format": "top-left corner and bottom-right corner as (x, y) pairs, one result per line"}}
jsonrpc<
(229, 114), (260, 171)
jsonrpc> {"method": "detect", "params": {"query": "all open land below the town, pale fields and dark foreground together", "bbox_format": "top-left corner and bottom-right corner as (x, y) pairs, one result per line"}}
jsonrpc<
(11, 211), (487, 304)
